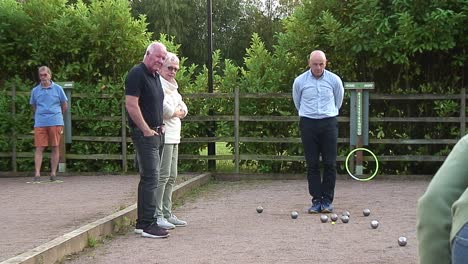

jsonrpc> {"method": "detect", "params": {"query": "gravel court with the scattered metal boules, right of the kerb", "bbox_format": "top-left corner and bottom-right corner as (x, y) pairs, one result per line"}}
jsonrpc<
(65, 180), (428, 264)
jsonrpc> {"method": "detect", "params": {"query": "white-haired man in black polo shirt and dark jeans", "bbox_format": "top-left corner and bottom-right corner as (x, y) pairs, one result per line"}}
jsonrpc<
(125, 42), (169, 238)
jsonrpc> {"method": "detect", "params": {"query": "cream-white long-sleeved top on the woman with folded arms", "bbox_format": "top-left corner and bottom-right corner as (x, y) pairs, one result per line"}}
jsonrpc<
(159, 76), (188, 144)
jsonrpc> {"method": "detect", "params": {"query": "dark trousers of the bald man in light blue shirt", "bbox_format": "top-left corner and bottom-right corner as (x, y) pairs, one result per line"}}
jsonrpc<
(299, 117), (338, 203)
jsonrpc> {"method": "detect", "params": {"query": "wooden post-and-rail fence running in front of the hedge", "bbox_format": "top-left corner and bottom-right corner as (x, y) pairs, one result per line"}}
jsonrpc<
(0, 88), (466, 176)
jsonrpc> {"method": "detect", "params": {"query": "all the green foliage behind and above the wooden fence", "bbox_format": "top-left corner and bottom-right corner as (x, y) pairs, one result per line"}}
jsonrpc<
(0, 0), (468, 174)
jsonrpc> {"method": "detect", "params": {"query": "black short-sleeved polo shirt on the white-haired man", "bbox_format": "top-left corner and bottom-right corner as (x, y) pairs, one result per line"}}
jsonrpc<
(125, 62), (164, 127)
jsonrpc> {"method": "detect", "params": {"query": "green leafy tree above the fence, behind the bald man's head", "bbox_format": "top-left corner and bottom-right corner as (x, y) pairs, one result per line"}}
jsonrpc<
(278, 0), (467, 92)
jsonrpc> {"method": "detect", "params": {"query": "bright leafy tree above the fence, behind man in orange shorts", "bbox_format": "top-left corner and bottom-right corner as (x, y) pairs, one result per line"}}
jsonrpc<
(0, 0), (150, 83)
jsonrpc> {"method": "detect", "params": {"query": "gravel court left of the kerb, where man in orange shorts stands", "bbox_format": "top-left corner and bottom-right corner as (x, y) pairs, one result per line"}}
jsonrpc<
(0, 175), (138, 262)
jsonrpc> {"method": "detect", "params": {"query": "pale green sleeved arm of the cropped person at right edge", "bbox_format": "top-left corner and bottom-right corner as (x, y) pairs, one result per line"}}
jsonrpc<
(416, 136), (468, 264)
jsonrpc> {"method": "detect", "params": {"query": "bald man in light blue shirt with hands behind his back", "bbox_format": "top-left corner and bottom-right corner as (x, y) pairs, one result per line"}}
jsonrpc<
(292, 50), (344, 213)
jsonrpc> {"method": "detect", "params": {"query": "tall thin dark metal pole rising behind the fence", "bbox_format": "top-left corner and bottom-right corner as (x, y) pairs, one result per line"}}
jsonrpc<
(206, 0), (216, 170)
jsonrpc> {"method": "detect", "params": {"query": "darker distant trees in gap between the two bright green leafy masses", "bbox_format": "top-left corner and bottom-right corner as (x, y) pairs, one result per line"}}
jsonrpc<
(132, 0), (299, 65)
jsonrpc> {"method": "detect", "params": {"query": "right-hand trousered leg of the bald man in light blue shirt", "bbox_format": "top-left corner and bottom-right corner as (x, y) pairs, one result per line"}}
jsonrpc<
(320, 118), (338, 204)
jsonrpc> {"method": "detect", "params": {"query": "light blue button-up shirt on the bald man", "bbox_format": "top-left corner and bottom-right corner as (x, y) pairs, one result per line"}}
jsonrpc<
(292, 70), (344, 119)
